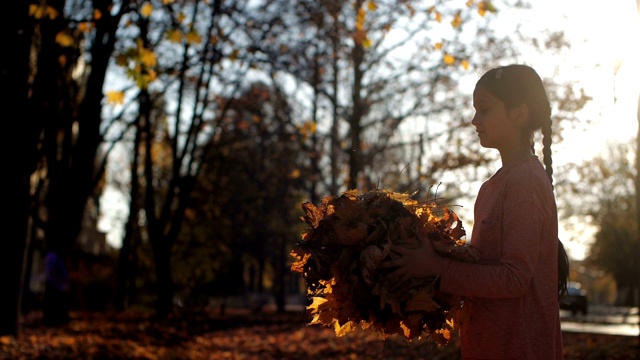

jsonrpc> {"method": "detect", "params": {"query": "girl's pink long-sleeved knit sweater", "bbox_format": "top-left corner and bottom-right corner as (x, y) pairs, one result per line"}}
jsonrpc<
(440, 156), (562, 360)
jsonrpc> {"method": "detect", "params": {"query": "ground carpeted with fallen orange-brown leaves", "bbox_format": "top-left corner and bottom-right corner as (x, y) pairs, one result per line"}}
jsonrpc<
(0, 311), (638, 360)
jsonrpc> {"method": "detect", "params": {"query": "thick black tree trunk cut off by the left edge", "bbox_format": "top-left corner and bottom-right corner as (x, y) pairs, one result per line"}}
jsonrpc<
(0, 0), (39, 336)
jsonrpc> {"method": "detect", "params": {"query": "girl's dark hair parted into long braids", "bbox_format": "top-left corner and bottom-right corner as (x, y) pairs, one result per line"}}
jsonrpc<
(476, 64), (569, 298)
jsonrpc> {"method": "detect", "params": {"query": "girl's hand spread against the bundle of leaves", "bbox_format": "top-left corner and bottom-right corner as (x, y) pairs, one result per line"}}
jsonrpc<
(380, 232), (445, 289)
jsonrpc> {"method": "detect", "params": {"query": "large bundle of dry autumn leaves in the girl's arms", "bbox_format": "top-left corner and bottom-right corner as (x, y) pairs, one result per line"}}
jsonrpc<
(291, 190), (479, 345)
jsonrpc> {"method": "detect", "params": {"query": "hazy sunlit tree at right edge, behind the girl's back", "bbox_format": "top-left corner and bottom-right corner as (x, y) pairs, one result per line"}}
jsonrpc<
(567, 143), (640, 306)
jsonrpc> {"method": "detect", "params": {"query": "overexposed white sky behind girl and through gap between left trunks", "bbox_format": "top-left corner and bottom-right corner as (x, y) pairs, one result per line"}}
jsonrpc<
(99, 0), (640, 259)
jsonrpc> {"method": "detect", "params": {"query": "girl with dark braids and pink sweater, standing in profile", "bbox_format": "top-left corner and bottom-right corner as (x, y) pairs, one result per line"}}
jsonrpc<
(385, 65), (567, 360)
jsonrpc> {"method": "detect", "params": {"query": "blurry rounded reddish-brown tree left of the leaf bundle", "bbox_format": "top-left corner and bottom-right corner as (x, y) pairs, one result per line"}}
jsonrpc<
(173, 83), (303, 311)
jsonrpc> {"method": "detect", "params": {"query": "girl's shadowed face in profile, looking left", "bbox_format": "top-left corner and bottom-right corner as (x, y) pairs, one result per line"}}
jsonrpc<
(471, 87), (519, 152)
